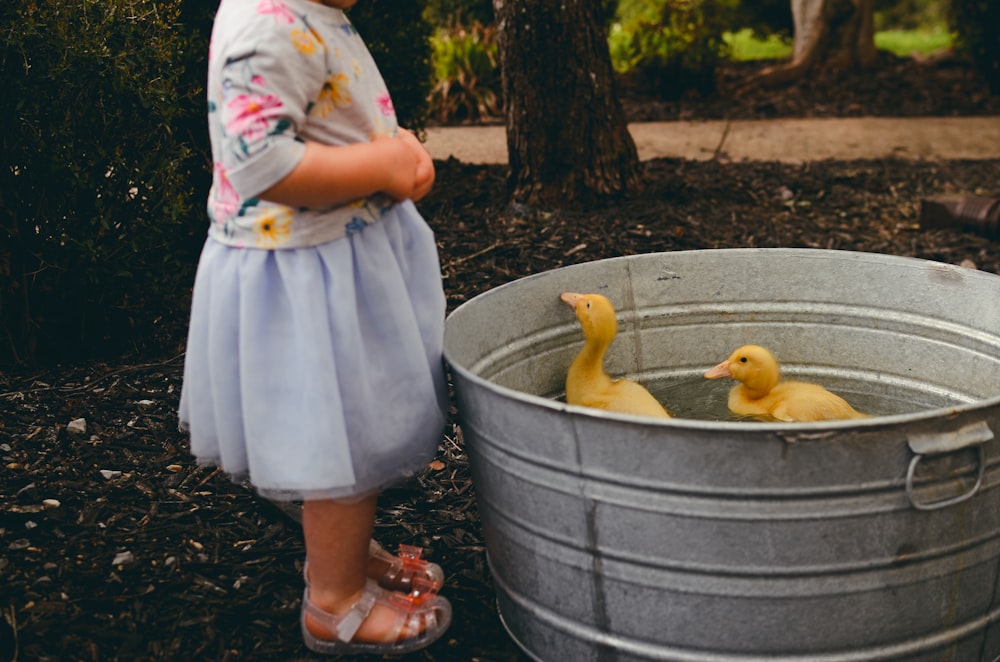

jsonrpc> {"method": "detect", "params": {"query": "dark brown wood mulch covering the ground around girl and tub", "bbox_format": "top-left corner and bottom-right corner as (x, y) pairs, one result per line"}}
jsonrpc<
(0, 53), (1000, 661)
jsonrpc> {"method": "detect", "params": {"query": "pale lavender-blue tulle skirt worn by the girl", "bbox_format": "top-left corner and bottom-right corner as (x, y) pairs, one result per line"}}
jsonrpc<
(180, 202), (448, 500)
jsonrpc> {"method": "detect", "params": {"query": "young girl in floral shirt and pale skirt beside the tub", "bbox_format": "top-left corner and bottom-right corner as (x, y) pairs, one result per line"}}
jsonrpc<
(180, 0), (451, 654)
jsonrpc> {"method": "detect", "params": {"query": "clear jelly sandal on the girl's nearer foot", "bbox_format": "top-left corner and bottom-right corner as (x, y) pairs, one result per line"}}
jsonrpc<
(299, 577), (451, 655)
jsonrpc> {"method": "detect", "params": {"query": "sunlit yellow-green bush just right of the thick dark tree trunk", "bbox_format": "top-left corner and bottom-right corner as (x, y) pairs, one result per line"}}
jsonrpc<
(609, 0), (736, 99)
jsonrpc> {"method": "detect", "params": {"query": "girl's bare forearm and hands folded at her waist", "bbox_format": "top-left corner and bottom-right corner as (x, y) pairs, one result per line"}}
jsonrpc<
(259, 129), (434, 207)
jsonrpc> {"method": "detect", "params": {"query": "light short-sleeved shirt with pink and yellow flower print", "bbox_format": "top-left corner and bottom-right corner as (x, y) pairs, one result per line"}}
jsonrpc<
(208, 0), (397, 249)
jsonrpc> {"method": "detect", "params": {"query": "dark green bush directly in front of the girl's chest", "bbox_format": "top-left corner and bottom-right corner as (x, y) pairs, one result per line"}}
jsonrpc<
(350, 0), (433, 134)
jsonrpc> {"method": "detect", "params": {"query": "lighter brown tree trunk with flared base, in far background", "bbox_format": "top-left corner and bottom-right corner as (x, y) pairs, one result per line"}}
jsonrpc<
(755, 0), (878, 85)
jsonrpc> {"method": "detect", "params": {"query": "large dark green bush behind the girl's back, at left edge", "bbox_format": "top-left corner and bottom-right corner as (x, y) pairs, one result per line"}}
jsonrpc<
(0, 0), (208, 363)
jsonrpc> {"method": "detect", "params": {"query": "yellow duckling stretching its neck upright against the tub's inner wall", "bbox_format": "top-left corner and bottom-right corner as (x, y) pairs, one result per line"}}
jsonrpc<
(559, 292), (670, 418)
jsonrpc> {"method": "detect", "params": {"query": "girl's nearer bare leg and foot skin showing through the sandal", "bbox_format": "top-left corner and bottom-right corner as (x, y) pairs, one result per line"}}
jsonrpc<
(302, 494), (414, 641)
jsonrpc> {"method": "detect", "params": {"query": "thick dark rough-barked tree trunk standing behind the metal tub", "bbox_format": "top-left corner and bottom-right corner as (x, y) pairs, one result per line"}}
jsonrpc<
(493, 0), (641, 209)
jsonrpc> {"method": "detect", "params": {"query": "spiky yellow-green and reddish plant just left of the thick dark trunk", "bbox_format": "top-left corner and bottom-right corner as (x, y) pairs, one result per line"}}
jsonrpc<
(429, 23), (503, 122)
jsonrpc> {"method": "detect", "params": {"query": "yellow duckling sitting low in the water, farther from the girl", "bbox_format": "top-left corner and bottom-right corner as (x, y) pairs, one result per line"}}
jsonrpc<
(705, 345), (868, 422)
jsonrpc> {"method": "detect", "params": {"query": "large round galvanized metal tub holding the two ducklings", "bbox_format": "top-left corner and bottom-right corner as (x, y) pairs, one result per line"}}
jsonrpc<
(445, 249), (1000, 662)
